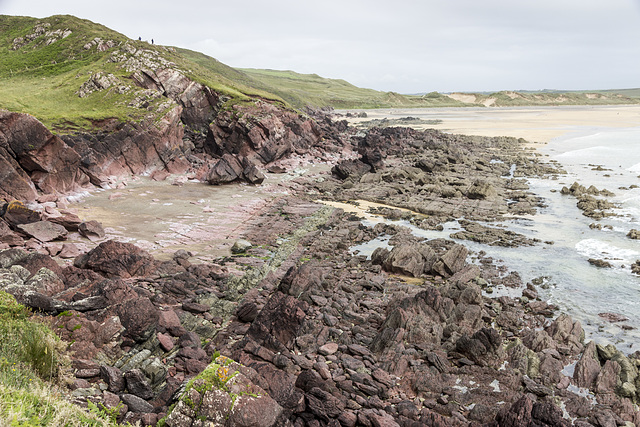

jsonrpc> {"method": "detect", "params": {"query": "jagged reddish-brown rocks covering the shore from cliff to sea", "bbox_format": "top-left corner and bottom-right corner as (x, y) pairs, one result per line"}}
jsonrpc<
(0, 103), (640, 427)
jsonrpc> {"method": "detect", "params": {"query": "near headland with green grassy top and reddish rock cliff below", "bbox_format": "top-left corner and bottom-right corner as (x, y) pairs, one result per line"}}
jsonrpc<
(0, 16), (344, 201)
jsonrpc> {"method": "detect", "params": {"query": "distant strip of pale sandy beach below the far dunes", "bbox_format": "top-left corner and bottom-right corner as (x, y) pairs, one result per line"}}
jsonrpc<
(340, 105), (640, 143)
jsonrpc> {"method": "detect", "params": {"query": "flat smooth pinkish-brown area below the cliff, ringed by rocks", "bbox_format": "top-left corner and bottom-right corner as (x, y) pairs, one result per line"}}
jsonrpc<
(71, 175), (286, 261)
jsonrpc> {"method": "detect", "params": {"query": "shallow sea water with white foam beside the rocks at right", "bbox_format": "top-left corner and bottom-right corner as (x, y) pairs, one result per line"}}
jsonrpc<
(353, 128), (640, 354)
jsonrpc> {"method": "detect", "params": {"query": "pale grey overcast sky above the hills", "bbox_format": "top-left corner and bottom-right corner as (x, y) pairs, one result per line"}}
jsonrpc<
(0, 0), (640, 93)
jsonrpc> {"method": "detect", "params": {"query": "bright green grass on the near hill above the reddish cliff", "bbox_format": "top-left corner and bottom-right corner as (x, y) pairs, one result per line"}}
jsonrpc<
(0, 15), (283, 132)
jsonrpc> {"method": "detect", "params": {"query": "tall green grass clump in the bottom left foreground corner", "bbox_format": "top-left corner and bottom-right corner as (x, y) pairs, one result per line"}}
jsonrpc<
(0, 291), (122, 427)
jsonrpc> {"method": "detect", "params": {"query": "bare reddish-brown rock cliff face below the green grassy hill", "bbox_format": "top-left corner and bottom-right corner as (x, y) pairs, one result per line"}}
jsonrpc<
(0, 52), (343, 201)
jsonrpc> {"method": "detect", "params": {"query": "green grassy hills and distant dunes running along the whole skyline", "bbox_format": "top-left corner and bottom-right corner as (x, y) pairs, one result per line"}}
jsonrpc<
(0, 15), (640, 132)
